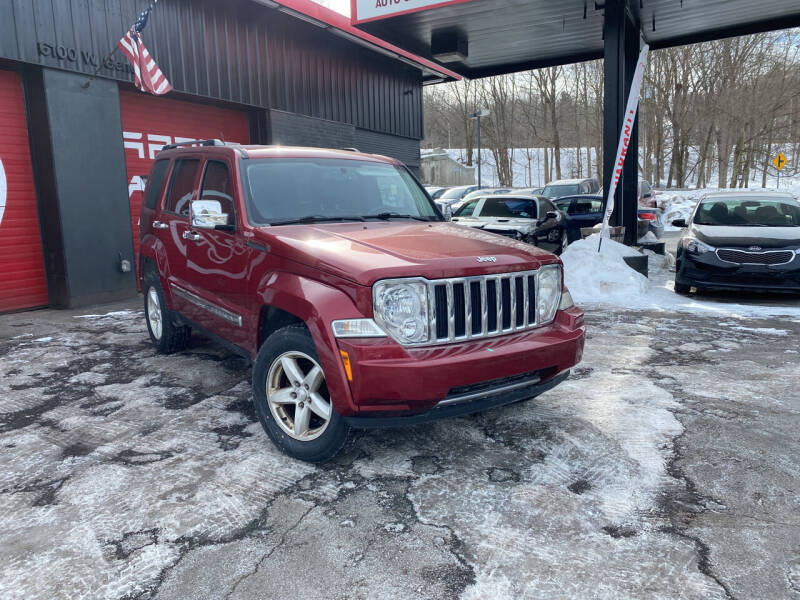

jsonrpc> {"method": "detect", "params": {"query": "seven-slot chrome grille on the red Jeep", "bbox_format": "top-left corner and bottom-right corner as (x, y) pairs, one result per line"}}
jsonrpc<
(428, 271), (538, 343)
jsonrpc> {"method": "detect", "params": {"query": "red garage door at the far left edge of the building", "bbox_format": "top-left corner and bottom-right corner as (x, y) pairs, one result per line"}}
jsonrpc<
(0, 71), (47, 312)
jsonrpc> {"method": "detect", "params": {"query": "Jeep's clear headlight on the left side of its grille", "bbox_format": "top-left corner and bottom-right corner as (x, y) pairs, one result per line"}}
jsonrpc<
(372, 279), (430, 344)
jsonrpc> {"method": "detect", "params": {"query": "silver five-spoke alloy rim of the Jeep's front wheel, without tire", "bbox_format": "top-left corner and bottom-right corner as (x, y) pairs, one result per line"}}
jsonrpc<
(266, 351), (333, 442)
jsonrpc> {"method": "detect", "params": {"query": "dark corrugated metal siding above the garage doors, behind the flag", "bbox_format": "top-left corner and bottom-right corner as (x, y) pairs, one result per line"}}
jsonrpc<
(0, 0), (422, 139)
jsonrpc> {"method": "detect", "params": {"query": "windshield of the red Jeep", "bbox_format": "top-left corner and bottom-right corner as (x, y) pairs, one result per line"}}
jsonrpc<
(243, 158), (440, 226)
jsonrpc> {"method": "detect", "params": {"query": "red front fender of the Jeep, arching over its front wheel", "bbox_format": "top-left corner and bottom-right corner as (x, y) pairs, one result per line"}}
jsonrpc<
(253, 272), (365, 416)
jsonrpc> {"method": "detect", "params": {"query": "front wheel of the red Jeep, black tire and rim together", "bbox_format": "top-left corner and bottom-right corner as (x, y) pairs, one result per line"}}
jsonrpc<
(253, 325), (350, 462)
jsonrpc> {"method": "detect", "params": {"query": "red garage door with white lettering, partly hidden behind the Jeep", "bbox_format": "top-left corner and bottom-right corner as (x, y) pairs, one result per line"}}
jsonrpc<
(119, 91), (250, 265)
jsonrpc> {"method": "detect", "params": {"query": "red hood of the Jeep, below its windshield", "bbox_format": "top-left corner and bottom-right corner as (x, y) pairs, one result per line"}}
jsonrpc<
(256, 221), (558, 285)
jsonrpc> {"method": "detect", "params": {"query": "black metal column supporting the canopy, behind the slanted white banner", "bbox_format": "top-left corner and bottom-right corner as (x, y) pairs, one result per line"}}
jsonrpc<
(603, 0), (640, 246)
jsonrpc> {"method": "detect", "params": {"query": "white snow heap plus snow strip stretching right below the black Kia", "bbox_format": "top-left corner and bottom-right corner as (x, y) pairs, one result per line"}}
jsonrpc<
(561, 234), (800, 317)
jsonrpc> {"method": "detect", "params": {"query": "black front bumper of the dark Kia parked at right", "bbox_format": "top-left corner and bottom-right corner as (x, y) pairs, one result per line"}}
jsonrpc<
(675, 250), (800, 292)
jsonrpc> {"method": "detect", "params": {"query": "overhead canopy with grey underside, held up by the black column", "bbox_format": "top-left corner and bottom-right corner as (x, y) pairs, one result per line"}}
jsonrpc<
(351, 0), (800, 77)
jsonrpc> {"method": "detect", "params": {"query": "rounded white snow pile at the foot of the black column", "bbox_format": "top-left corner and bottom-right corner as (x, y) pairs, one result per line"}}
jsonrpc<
(561, 233), (648, 305)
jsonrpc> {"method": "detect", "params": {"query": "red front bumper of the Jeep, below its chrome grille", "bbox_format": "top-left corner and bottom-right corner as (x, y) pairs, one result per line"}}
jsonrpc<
(339, 307), (585, 426)
